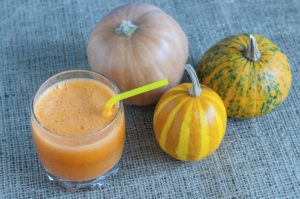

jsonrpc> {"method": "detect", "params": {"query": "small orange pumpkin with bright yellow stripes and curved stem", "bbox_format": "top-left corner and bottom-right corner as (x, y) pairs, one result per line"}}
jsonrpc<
(153, 65), (227, 161)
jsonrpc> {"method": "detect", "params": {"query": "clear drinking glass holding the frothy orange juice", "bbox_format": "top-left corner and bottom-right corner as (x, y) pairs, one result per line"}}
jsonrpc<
(31, 70), (125, 189)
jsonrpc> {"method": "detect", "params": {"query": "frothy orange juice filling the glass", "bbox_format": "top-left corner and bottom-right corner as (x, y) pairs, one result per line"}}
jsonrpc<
(32, 78), (125, 181)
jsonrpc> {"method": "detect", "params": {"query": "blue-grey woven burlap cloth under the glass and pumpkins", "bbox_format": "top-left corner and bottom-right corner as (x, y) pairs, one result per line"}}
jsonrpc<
(0, 0), (300, 198)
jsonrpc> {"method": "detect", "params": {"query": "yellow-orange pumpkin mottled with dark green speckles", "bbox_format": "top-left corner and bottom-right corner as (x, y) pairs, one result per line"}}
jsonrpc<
(198, 34), (292, 118)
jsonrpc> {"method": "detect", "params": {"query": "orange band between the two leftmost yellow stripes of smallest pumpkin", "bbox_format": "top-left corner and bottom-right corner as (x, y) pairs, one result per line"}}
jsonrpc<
(158, 98), (188, 150)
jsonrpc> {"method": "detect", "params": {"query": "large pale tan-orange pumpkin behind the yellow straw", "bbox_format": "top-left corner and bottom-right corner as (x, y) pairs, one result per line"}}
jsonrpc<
(87, 3), (188, 105)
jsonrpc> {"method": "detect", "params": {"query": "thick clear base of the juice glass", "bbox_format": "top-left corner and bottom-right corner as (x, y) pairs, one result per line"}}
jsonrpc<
(46, 163), (120, 191)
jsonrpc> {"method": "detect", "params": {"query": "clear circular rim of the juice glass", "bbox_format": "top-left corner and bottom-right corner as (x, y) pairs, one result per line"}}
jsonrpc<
(31, 69), (123, 139)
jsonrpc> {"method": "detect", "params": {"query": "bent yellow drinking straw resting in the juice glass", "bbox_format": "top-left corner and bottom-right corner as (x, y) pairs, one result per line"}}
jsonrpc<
(103, 79), (169, 115)
